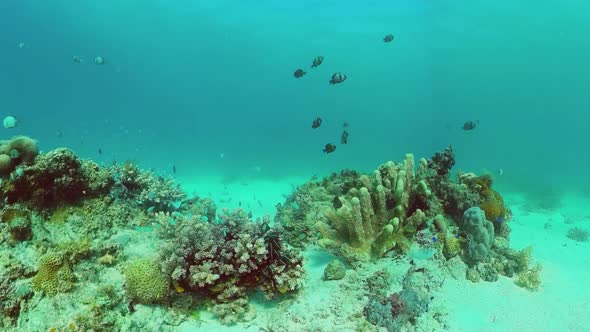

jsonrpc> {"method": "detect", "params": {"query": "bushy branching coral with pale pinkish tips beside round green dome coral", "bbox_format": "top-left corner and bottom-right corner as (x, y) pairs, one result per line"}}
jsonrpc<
(157, 209), (304, 322)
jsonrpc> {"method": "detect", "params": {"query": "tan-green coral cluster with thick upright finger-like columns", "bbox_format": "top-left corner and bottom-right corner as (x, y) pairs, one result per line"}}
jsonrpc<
(316, 154), (440, 261)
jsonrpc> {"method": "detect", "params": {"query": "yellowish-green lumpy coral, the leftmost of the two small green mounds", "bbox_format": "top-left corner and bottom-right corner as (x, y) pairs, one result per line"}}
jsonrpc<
(32, 253), (74, 295)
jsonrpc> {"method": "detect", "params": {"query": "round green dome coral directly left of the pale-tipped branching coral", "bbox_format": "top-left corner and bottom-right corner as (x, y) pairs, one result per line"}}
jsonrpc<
(125, 258), (170, 303)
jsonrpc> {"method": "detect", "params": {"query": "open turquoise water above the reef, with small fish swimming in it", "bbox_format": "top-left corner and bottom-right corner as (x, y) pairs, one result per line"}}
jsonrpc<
(0, 0), (590, 330)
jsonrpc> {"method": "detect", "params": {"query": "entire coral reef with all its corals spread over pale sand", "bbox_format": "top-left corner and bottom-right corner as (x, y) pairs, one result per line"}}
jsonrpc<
(0, 141), (541, 331)
